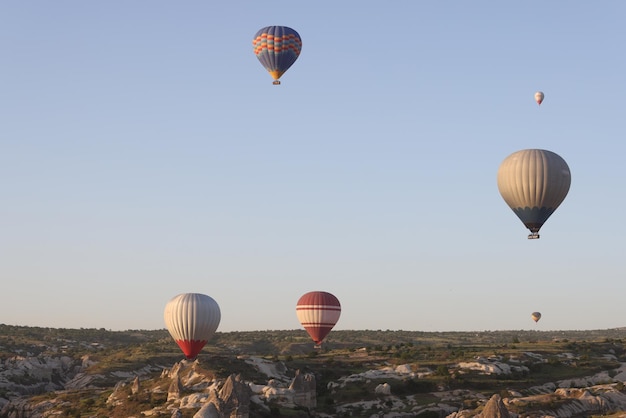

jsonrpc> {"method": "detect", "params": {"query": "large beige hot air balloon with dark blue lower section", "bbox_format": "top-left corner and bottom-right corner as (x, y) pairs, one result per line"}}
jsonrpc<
(498, 149), (571, 239)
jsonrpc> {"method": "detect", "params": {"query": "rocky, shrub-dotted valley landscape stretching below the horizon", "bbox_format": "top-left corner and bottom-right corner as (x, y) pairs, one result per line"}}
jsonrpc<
(0, 325), (626, 418)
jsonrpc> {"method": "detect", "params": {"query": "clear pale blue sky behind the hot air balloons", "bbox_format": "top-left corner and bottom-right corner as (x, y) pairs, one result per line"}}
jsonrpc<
(0, 0), (626, 331)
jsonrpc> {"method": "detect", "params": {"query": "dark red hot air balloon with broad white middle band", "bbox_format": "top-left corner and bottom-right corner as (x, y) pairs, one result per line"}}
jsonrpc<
(296, 292), (341, 345)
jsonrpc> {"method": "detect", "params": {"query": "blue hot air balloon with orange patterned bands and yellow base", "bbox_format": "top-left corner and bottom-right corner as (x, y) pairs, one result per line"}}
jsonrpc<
(252, 26), (302, 84)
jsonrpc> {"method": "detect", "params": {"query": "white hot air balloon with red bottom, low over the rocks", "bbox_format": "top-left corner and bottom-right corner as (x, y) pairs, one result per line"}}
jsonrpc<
(163, 293), (221, 360)
